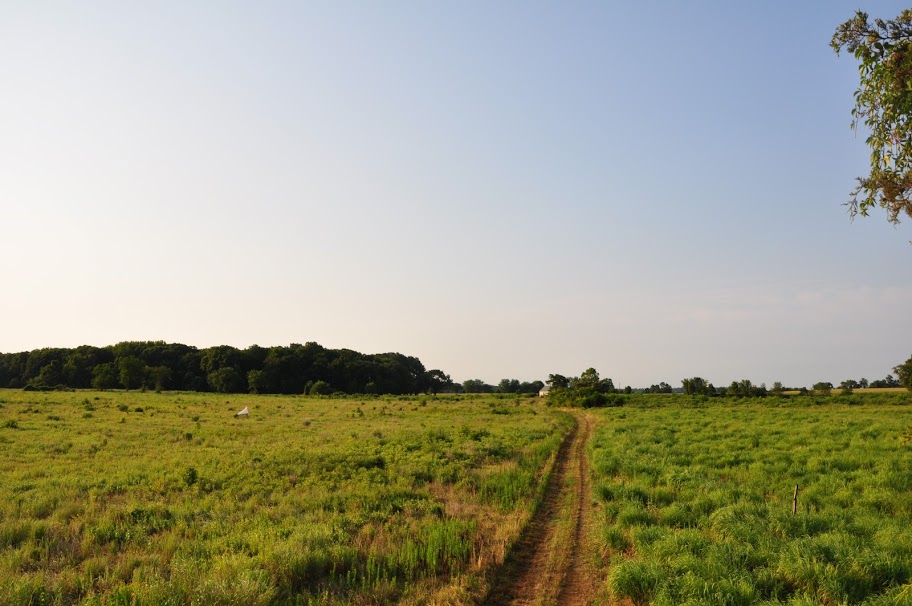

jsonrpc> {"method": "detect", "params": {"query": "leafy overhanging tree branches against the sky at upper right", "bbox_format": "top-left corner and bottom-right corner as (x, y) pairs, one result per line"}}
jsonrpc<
(830, 10), (912, 223)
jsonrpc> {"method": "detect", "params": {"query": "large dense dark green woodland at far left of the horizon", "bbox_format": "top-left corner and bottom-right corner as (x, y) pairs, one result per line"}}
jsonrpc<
(0, 341), (458, 394)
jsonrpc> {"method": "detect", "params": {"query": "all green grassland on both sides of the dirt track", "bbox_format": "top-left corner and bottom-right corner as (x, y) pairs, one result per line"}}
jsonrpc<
(7, 390), (912, 606)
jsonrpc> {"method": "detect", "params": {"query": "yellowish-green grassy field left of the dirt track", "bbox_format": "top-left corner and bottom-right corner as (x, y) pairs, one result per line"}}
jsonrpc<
(0, 391), (572, 605)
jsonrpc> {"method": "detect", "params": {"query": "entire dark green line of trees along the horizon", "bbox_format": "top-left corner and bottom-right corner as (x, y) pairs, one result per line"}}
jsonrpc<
(0, 341), (912, 406)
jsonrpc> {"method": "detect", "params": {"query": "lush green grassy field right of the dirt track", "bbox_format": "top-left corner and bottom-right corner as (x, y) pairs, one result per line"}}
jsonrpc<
(590, 394), (912, 606)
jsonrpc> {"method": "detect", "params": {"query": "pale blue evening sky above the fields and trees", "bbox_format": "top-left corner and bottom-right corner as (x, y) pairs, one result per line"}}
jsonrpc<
(0, 0), (912, 386)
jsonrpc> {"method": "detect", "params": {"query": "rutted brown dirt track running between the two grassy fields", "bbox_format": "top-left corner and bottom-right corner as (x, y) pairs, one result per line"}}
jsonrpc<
(483, 414), (595, 606)
